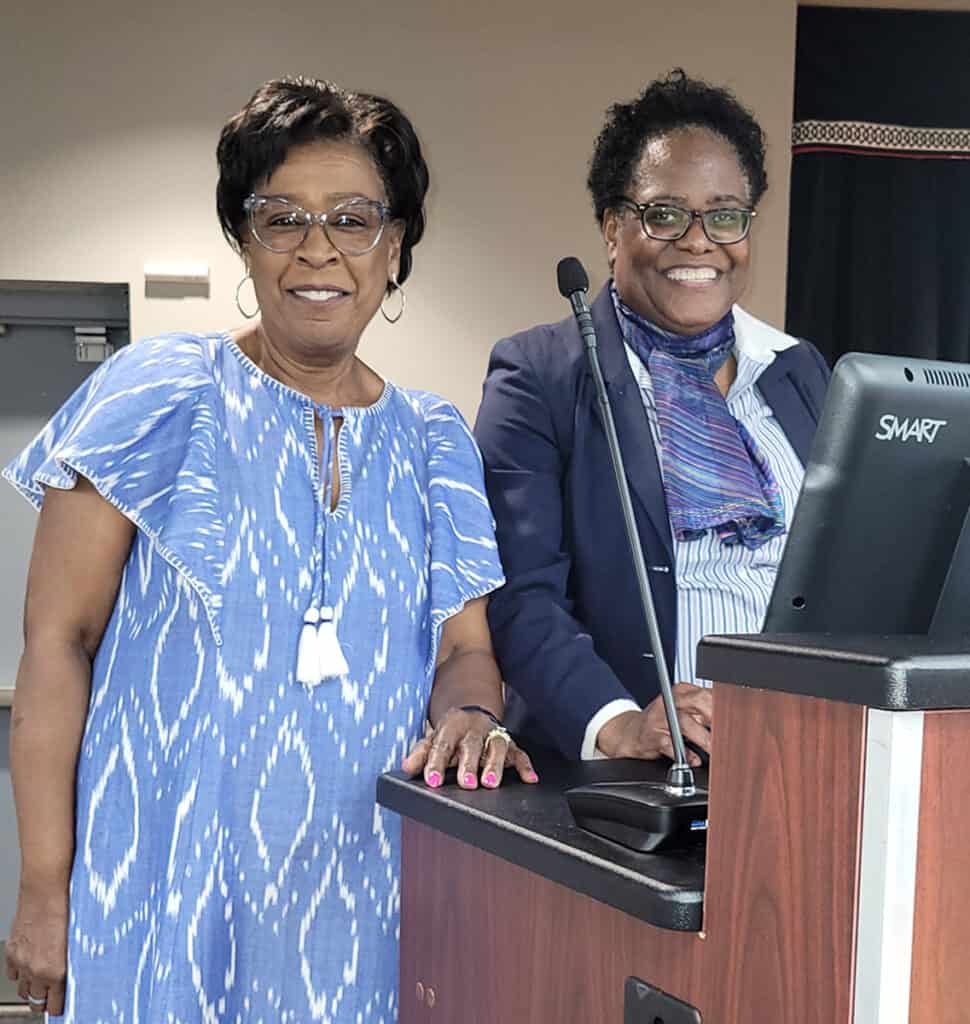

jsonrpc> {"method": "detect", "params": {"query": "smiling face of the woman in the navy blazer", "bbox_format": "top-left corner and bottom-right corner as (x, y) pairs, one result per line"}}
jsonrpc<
(603, 128), (751, 335)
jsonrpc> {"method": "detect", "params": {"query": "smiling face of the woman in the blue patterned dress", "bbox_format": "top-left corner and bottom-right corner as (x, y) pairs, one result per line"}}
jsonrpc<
(243, 142), (403, 359)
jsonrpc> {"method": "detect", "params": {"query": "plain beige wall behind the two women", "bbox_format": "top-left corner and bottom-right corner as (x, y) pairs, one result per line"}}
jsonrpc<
(0, 0), (796, 417)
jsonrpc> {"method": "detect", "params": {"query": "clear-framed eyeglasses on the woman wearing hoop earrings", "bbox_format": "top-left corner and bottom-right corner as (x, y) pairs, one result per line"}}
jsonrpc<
(243, 193), (390, 256)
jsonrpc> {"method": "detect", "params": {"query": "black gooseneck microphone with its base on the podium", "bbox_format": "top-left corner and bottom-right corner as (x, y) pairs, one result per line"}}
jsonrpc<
(556, 256), (707, 851)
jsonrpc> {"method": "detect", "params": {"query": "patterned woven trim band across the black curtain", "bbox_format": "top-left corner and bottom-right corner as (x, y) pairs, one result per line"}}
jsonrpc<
(792, 121), (970, 160)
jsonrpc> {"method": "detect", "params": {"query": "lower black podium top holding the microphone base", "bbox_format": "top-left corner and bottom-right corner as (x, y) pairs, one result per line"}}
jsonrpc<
(377, 751), (707, 932)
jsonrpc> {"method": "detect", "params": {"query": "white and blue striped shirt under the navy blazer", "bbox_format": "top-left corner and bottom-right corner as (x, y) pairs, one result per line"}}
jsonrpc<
(581, 307), (805, 760)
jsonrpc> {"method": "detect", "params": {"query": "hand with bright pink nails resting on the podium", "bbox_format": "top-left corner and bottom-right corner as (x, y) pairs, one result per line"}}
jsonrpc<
(400, 708), (539, 790)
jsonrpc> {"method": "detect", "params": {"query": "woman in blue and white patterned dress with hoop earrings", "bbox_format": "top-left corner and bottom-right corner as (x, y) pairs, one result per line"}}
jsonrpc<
(5, 80), (536, 1024)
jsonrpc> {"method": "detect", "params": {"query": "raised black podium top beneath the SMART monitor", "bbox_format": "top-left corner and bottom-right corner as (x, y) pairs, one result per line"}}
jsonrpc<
(698, 633), (970, 711)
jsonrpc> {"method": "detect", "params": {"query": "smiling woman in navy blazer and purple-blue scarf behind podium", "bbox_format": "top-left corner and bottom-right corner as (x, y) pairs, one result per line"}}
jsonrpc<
(475, 72), (829, 763)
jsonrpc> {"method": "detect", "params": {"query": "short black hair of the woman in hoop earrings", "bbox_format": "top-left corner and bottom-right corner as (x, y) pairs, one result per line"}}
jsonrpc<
(215, 77), (428, 287)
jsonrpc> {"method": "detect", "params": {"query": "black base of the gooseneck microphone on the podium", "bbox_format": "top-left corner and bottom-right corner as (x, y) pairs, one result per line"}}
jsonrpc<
(565, 782), (708, 853)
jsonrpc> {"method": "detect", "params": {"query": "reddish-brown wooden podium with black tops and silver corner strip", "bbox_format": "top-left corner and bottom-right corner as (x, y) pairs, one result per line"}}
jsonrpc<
(378, 636), (970, 1024)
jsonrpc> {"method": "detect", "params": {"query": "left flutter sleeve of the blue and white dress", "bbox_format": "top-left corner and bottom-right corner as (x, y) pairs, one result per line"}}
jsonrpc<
(3, 335), (224, 642)
